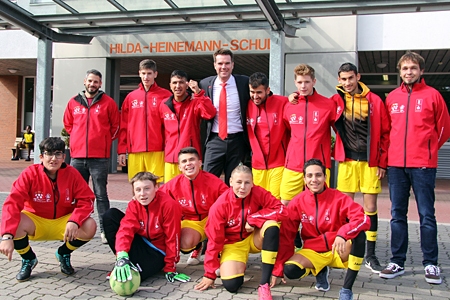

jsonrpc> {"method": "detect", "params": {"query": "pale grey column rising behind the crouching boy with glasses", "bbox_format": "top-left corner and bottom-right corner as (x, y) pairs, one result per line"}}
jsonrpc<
(34, 38), (53, 163)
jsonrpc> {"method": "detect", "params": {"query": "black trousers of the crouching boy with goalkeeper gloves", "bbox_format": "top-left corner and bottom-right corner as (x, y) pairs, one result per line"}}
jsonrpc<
(103, 208), (164, 281)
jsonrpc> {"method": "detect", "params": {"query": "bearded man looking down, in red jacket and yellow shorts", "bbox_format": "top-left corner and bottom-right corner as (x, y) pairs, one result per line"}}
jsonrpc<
(247, 72), (289, 199)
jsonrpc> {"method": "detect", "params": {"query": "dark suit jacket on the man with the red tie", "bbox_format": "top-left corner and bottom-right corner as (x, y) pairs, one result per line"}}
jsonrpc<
(199, 74), (250, 149)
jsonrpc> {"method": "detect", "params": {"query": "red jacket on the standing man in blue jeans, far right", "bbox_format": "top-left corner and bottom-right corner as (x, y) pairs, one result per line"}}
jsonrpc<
(386, 79), (450, 168)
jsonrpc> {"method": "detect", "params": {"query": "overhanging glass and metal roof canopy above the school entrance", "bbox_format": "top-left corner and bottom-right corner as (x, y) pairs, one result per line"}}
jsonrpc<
(0, 0), (450, 43)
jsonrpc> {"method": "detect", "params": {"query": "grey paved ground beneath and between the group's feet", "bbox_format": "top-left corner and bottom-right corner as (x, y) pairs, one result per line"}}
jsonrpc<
(0, 162), (450, 300)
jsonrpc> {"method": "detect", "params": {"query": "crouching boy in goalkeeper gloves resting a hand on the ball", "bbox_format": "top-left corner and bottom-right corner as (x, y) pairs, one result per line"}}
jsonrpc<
(103, 172), (190, 282)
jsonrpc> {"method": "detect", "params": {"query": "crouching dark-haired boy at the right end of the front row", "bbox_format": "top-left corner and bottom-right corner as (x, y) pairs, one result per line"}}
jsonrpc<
(271, 159), (370, 300)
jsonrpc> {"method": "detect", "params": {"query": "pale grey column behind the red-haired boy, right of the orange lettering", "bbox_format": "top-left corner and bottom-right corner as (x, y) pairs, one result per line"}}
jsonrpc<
(269, 30), (285, 95)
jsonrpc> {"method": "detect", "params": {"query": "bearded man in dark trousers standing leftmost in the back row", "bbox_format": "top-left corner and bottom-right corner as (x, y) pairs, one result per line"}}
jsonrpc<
(63, 69), (120, 244)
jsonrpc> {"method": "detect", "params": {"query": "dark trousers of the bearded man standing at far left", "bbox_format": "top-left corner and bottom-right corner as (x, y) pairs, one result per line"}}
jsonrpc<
(70, 158), (109, 232)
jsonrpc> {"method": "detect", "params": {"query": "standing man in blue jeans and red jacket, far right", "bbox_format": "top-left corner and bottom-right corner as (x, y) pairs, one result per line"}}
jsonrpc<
(380, 51), (450, 284)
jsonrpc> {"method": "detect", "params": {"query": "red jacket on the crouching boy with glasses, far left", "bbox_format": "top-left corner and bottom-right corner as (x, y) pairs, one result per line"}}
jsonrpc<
(1, 163), (95, 236)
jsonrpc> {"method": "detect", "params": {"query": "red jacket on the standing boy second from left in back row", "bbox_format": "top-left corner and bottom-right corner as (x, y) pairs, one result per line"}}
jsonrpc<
(117, 82), (172, 154)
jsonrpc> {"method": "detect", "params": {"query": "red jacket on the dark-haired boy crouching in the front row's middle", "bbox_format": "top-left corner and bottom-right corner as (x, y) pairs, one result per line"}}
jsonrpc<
(160, 170), (228, 221)
